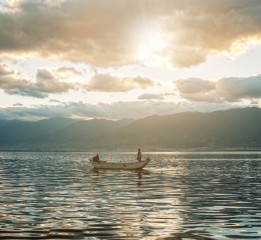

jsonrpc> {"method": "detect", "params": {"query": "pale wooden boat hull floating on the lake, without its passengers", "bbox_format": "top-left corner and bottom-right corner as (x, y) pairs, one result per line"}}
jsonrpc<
(89, 158), (150, 170)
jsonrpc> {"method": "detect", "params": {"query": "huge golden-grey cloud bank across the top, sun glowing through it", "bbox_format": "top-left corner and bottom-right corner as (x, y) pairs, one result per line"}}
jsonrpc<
(0, 0), (261, 67)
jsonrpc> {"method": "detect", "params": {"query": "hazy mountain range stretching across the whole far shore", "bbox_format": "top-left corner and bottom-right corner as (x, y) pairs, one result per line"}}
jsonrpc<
(0, 108), (261, 151)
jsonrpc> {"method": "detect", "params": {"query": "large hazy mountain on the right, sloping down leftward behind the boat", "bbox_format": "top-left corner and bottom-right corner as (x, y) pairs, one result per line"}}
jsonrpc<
(93, 108), (261, 149)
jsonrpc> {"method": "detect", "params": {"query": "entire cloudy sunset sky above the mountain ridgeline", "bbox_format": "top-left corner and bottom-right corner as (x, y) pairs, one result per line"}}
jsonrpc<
(0, 0), (261, 120)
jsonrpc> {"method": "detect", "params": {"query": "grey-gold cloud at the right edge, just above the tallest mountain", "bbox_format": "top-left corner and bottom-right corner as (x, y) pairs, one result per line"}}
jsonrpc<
(174, 75), (261, 102)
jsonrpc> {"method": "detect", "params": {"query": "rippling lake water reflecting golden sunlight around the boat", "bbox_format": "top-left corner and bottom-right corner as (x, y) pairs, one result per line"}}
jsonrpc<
(0, 152), (261, 240)
